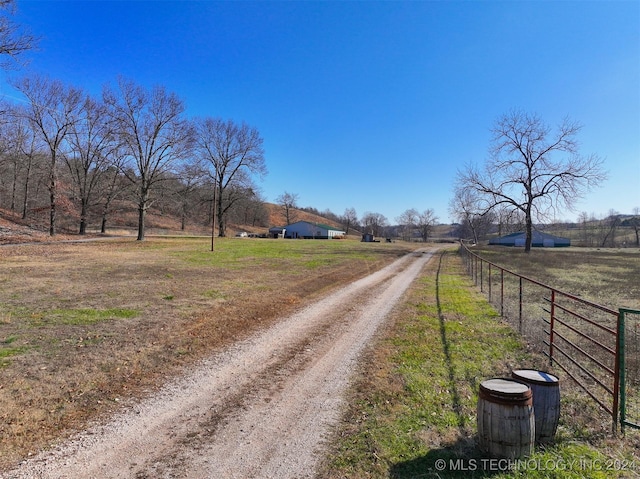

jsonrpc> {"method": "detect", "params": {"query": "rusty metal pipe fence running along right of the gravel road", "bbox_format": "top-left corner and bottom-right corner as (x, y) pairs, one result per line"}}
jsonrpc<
(460, 243), (640, 432)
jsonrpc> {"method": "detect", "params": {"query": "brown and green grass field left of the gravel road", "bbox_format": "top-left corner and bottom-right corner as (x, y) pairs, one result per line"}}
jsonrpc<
(0, 237), (420, 468)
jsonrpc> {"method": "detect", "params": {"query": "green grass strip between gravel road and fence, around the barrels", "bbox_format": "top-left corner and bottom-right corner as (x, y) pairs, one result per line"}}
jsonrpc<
(322, 251), (640, 479)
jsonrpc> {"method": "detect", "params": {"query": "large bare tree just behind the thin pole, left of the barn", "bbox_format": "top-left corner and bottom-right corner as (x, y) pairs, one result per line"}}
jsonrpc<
(196, 118), (267, 237)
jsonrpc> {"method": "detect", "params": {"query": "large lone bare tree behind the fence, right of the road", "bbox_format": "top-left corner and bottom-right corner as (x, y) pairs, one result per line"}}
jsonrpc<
(456, 110), (606, 252)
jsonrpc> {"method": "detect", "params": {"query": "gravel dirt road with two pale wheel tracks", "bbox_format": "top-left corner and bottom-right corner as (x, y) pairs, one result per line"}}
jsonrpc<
(1, 250), (434, 479)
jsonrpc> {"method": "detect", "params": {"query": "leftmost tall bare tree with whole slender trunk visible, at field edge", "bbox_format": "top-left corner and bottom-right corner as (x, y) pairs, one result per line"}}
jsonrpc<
(15, 76), (82, 236)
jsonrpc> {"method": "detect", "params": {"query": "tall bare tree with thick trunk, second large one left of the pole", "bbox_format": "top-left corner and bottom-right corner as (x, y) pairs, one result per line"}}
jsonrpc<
(103, 78), (193, 241)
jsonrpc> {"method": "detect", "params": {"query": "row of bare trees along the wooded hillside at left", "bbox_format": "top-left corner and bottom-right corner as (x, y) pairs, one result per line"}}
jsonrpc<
(0, 75), (268, 240)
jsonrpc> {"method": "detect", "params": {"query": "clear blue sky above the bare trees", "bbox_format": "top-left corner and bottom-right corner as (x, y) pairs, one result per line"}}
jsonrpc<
(0, 0), (640, 223)
